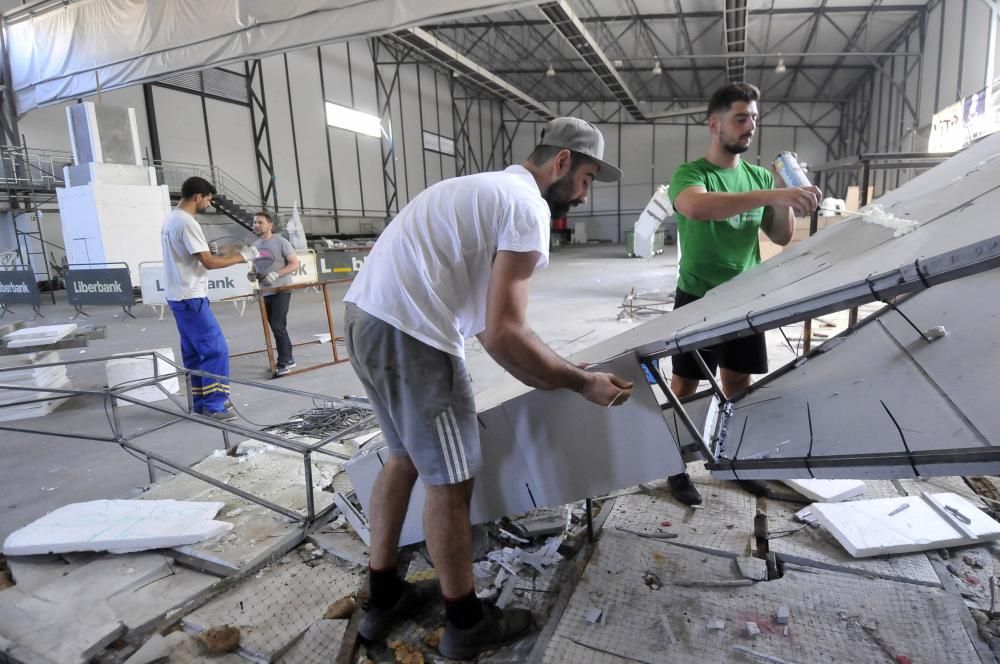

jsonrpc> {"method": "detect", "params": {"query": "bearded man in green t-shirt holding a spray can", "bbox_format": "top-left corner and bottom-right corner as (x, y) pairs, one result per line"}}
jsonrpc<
(669, 83), (821, 505)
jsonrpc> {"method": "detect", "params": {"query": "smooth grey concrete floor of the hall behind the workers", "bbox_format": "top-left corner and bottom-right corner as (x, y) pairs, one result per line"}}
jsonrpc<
(0, 245), (684, 539)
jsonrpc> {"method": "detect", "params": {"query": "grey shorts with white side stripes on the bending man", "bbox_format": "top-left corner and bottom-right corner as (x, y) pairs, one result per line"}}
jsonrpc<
(345, 302), (482, 485)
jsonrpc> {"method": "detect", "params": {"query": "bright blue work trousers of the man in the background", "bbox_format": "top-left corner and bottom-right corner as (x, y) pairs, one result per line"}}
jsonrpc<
(167, 297), (229, 413)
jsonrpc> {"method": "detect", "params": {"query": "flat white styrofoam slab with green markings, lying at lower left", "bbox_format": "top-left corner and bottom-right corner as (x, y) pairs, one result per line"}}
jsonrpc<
(3, 500), (233, 556)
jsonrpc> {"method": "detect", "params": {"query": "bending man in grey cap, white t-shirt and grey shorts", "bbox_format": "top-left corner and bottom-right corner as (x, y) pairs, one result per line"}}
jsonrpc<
(344, 118), (632, 659)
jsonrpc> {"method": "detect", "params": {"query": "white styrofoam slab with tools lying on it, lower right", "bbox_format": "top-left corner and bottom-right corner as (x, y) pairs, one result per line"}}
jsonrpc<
(810, 493), (1000, 558)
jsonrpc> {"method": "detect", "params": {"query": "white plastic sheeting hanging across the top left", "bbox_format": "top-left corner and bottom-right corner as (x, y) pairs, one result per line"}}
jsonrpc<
(4, 0), (530, 115)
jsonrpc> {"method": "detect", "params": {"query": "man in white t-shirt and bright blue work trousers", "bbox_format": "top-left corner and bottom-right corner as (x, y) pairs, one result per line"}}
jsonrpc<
(160, 177), (260, 421)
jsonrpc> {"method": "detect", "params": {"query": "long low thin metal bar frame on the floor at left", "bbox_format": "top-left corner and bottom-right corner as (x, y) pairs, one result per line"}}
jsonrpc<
(0, 351), (374, 525)
